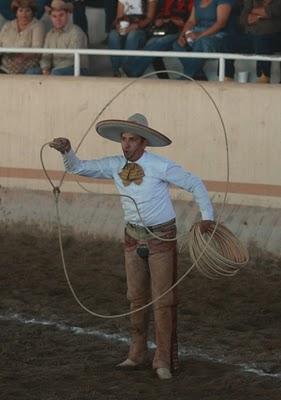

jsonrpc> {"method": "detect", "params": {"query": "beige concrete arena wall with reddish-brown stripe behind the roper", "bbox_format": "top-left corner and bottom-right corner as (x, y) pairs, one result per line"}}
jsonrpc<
(0, 76), (281, 253)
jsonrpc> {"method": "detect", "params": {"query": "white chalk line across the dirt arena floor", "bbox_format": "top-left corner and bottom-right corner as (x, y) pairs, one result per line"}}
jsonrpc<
(0, 313), (281, 379)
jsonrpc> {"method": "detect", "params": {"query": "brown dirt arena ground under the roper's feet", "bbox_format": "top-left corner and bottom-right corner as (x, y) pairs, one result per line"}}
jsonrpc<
(0, 230), (281, 400)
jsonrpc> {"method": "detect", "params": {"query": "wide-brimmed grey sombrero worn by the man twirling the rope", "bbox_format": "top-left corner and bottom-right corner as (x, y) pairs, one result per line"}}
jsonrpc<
(96, 114), (172, 147)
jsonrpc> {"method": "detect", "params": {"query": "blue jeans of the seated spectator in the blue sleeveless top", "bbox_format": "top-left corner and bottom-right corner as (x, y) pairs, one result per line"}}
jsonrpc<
(173, 29), (224, 78)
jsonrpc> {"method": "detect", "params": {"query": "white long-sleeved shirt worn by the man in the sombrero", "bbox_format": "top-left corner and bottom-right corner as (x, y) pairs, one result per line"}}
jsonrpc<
(63, 150), (214, 226)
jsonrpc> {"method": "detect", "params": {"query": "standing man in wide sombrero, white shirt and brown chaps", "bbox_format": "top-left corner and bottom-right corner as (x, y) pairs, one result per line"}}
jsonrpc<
(50, 114), (214, 379)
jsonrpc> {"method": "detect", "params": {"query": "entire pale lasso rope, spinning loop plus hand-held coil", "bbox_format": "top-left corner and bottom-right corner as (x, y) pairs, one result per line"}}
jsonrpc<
(40, 70), (249, 319)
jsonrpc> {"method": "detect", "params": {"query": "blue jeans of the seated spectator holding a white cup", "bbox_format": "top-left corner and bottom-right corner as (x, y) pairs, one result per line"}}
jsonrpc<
(108, 29), (146, 73)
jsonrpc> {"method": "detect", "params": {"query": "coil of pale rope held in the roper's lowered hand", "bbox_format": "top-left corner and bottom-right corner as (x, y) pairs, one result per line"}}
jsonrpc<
(188, 224), (249, 279)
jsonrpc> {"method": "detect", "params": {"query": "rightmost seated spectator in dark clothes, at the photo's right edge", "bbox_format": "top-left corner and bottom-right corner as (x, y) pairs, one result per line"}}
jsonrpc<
(239, 0), (281, 83)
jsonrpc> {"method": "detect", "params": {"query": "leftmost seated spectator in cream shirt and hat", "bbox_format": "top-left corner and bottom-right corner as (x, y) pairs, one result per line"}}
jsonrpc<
(0, 0), (45, 74)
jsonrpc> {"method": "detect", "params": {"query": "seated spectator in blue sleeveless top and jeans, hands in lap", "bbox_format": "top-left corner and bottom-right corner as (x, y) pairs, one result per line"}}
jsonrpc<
(173, 0), (233, 79)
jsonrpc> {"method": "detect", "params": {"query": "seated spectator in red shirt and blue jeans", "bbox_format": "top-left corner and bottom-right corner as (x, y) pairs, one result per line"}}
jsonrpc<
(123, 0), (193, 78)
